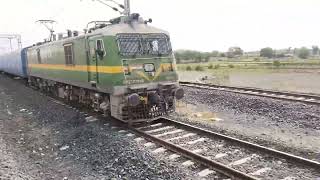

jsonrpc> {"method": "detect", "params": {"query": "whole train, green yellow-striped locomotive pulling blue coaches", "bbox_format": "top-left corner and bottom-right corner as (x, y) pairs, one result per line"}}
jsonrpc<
(0, 14), (184, 123)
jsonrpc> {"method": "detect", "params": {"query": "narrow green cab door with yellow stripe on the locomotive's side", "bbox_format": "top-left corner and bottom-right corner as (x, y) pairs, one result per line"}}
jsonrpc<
(88, 37), (99, 87)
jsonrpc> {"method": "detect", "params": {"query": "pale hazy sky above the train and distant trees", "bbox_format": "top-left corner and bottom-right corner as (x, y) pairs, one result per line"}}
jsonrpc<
(0, 0), (320, 51)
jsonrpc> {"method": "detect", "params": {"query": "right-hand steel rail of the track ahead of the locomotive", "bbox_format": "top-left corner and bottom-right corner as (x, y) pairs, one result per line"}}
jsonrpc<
(160, 118), (320, 171)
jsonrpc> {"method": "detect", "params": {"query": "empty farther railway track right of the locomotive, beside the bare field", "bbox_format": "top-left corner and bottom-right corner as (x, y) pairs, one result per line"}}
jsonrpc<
(180, 81), (320, 105)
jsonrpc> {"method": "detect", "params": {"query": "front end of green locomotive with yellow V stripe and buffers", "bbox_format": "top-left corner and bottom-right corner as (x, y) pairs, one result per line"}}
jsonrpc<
(103, 15), (184, 122)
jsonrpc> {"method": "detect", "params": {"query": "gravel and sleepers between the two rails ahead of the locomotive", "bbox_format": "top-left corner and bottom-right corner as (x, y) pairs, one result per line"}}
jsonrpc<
(143, 121), (320, 179)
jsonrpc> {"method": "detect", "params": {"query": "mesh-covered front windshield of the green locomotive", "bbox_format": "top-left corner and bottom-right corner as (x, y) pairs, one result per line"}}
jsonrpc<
(117, 34), (172, 56)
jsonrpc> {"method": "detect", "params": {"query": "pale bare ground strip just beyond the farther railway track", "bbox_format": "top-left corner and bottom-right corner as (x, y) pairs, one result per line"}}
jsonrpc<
(179, 69), (320, 94)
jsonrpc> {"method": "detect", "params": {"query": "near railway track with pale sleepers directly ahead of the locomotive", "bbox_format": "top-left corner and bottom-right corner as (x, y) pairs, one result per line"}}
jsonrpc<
(130, 119), (320, 180)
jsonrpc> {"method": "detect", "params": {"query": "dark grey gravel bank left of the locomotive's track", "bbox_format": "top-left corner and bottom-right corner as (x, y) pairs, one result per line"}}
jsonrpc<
(0, 75), (190, 179)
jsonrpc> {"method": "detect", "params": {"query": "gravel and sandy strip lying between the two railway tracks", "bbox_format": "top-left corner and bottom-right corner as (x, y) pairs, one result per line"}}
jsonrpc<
(173, 87), (320, 161)
